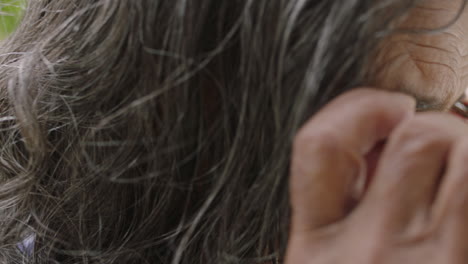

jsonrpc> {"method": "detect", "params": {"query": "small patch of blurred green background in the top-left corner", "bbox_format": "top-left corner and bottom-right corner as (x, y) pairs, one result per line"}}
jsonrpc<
(0, 0), (24, 39)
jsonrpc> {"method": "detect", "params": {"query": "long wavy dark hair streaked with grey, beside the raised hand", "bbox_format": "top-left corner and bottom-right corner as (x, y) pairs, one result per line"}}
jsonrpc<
(0, 0), (428, 264)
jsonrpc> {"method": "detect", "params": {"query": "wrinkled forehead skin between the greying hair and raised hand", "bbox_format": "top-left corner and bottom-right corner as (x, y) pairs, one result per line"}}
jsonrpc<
(368, 0), (468, 111)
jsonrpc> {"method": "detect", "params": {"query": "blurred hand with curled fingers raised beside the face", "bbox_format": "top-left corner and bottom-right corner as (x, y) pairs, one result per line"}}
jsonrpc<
(285, 89), (468, 264)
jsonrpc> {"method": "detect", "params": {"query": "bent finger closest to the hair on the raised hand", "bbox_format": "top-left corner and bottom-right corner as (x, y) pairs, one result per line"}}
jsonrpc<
(290, 89), (415, 232)
